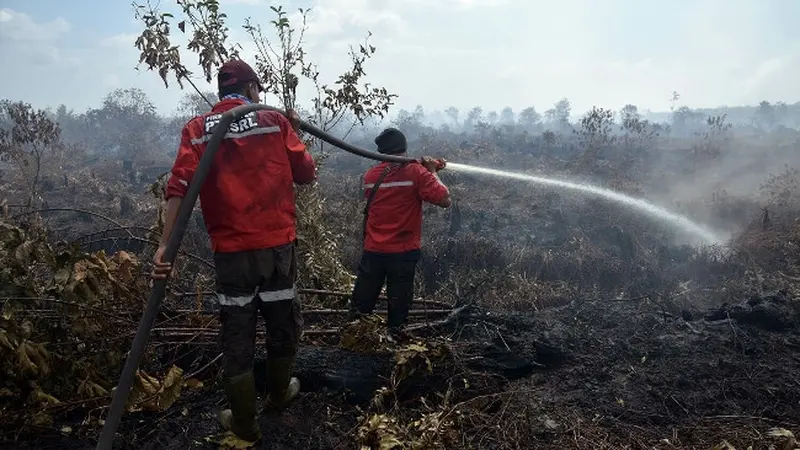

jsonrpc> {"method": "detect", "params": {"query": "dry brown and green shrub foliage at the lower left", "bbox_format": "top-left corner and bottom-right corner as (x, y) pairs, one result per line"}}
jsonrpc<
(0, 220), (147, 429)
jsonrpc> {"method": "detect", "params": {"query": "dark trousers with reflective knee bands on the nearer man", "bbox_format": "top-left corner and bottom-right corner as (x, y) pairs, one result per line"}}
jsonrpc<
(214, 244), (303, 377)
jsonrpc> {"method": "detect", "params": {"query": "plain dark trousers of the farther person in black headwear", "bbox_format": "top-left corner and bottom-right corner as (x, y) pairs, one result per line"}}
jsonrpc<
(351, 250), (420, 328)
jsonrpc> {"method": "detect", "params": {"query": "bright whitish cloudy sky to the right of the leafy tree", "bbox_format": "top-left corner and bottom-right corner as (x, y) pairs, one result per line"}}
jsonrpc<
(212, 0), (797, 114)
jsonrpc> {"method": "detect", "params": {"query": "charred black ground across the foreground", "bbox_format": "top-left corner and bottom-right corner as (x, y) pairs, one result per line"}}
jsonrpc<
(12, 286), (800, 449)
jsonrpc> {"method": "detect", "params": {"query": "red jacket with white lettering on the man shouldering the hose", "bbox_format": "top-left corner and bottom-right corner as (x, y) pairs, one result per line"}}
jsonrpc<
(166, 99), (316, 252)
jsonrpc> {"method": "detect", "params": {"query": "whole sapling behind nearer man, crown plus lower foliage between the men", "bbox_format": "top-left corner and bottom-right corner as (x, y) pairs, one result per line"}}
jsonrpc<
(134, 0), (397, 288)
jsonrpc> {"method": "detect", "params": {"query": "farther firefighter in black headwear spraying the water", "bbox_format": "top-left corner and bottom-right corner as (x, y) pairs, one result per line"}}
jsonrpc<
(350, 128), (451, 334)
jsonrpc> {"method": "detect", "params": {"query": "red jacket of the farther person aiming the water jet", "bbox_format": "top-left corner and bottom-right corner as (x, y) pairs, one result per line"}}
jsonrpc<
(364, 163), (449, 253)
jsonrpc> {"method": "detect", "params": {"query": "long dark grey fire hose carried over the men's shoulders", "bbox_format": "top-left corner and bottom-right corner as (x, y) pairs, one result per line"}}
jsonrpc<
(96, 104), (441, 450)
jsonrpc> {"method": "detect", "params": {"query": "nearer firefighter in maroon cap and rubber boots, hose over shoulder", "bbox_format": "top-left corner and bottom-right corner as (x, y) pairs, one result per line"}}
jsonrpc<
(152, 60), (316, 441)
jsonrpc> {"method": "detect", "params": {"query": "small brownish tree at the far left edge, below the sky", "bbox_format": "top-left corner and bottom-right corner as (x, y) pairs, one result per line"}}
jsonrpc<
(0, 100), (63, 206)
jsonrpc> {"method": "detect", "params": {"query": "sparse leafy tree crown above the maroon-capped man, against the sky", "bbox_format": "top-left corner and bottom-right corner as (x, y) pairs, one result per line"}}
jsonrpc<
(134, 0), (397, 141)
